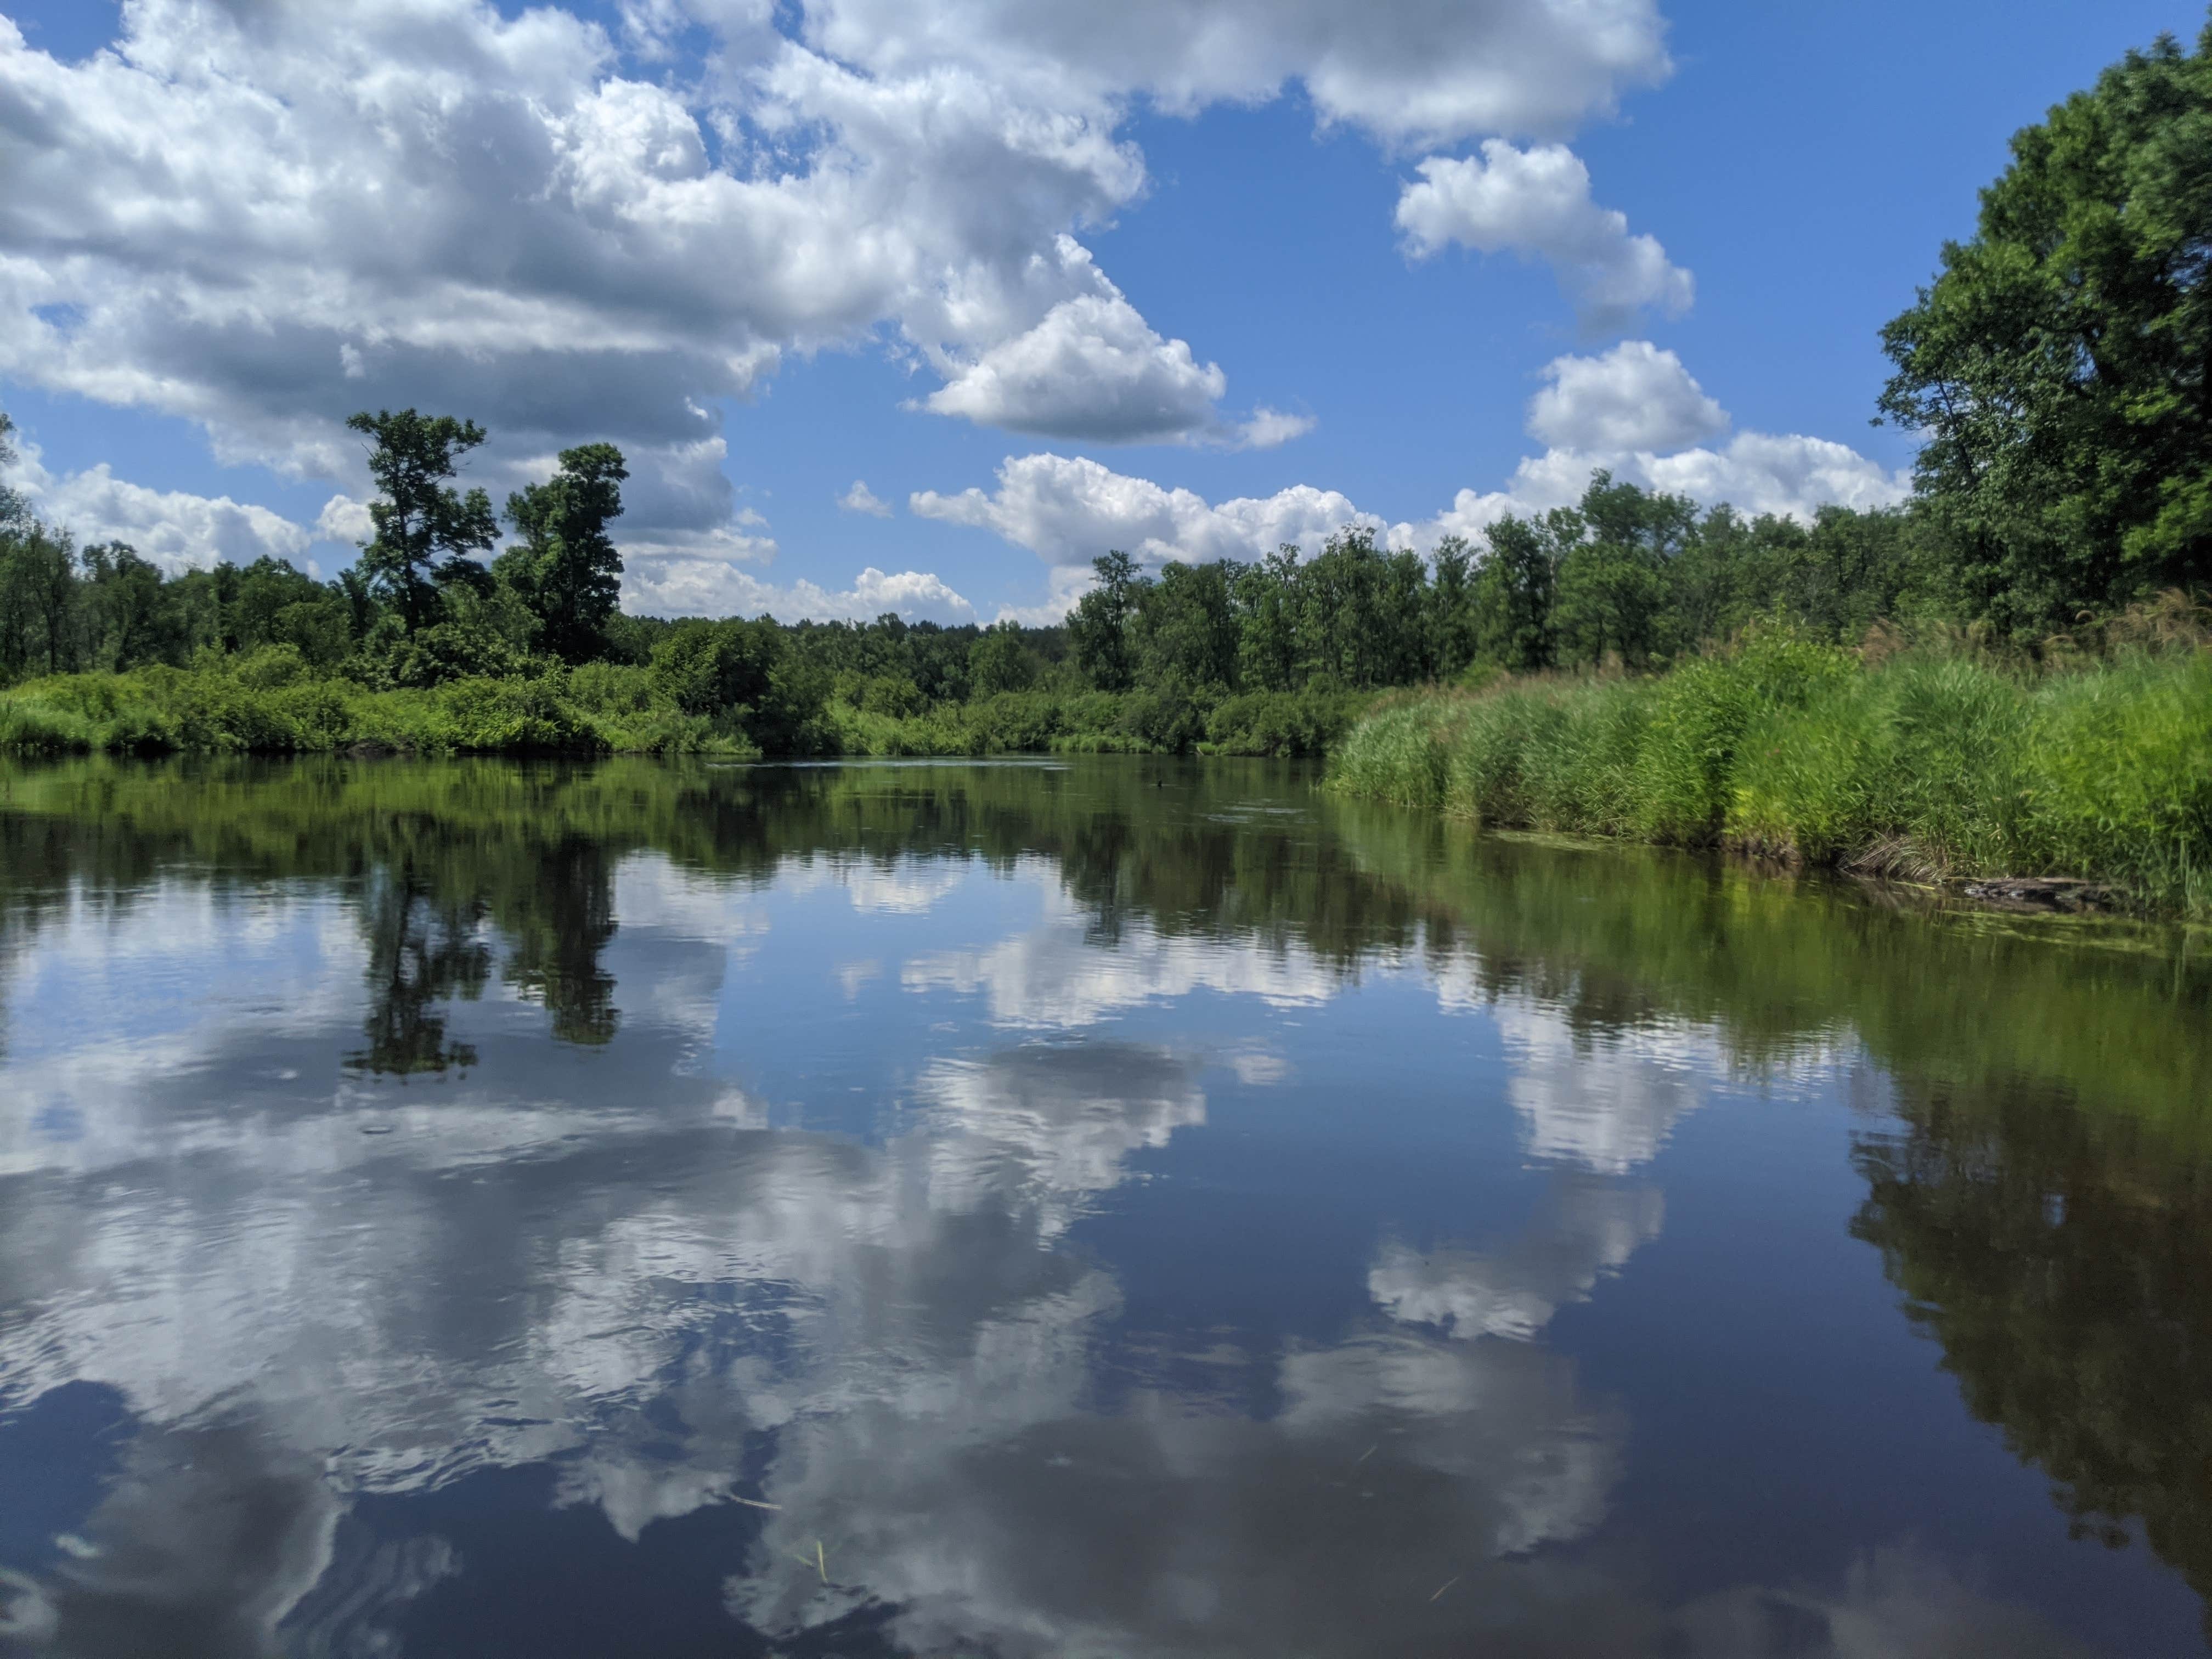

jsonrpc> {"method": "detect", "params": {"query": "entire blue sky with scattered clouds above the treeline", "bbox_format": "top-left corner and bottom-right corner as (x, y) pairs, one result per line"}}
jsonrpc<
(0, 0), (2205, 622)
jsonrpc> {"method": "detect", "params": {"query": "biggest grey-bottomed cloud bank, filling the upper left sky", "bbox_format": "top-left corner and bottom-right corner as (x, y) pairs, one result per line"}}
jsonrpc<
(0, 0), (1144, 531)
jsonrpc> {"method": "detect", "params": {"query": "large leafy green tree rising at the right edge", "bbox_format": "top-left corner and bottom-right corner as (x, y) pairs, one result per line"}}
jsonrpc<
(1882, 26), (2212, 633)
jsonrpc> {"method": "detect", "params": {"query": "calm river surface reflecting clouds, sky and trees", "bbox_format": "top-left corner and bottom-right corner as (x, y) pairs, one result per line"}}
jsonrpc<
(0, 761), (2212, 1659)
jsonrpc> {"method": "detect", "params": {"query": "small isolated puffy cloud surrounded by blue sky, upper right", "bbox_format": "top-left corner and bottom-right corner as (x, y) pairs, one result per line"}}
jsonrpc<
(1398, 139), (1695, 334)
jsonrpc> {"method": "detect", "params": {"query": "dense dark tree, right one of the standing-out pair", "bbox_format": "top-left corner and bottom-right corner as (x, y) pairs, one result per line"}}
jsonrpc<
(493, 444), (630, 664)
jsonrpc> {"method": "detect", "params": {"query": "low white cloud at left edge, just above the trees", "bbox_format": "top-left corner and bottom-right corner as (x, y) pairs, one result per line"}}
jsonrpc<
(7, 440), (314, 575)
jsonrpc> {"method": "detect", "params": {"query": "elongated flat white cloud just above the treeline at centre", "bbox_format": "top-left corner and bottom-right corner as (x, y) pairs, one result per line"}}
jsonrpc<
(907, 454), (1380, 566)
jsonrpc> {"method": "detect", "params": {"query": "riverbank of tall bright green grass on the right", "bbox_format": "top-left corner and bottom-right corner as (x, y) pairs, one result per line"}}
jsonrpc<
(1329, 635), (2212, 918)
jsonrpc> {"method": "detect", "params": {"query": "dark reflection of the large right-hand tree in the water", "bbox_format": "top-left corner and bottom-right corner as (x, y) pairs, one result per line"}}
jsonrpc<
(1852, 1080), (2212, 1637)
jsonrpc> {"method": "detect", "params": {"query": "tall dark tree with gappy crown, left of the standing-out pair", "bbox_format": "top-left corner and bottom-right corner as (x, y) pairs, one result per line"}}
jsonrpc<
(345, 409), (498, 633)
